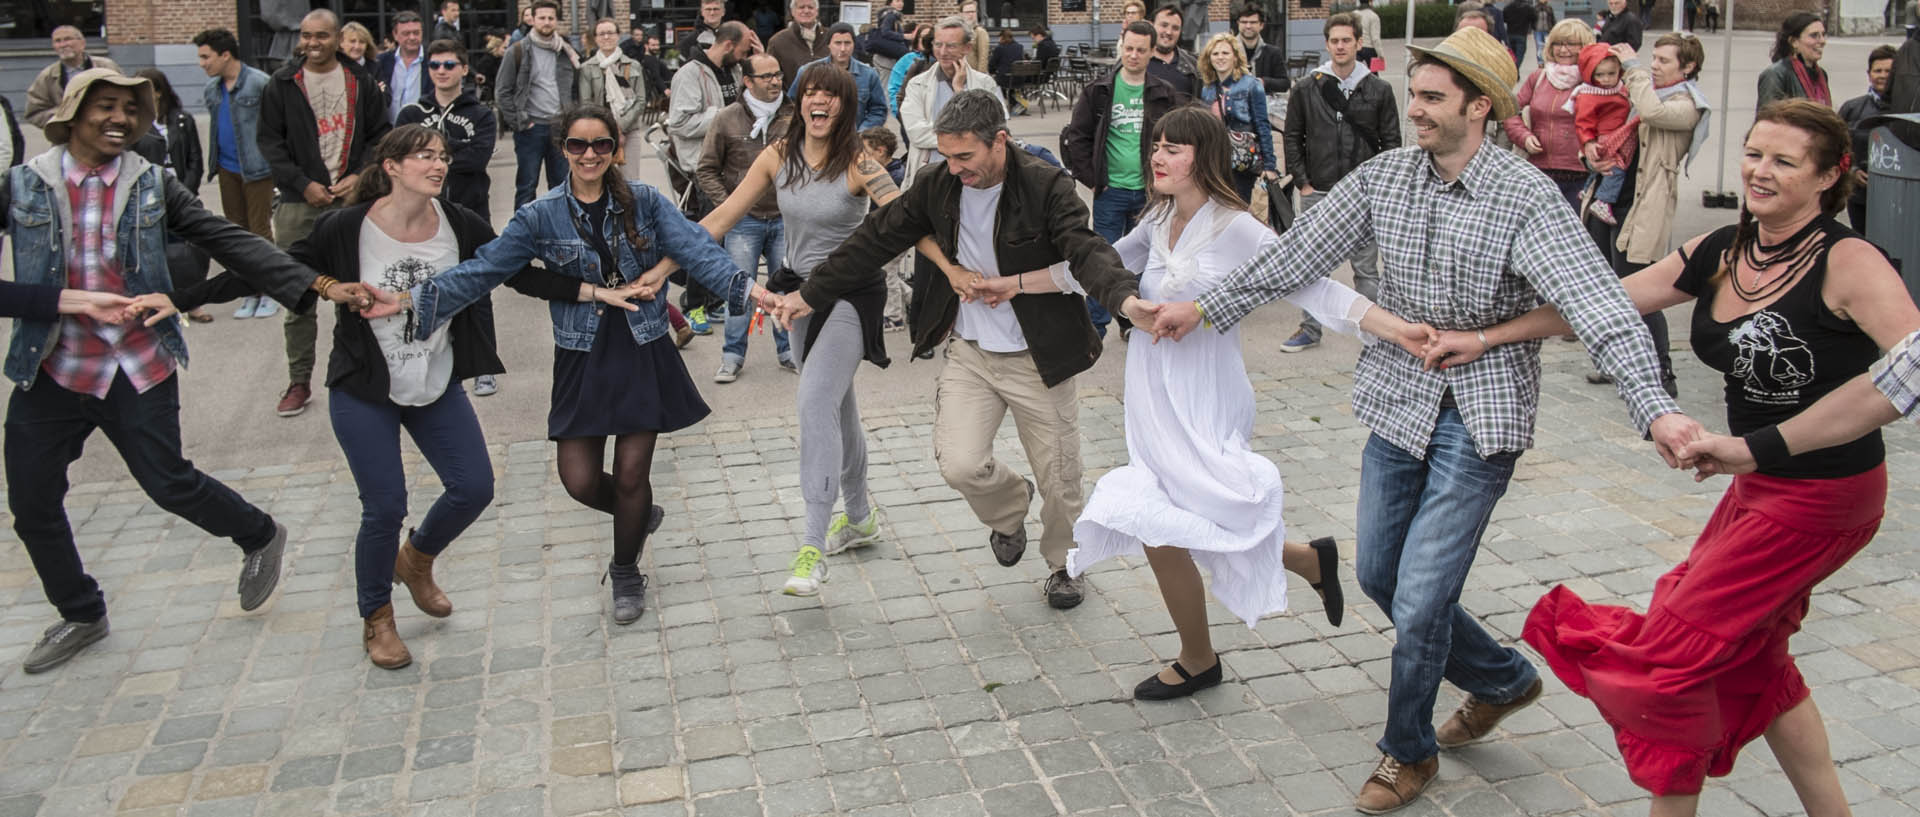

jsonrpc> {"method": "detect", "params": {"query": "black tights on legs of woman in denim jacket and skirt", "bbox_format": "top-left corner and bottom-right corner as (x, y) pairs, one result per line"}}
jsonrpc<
(559, 432), (659, 564)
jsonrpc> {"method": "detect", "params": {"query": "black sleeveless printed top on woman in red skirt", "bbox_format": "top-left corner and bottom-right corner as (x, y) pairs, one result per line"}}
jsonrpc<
(1674, 217), (1887, 479)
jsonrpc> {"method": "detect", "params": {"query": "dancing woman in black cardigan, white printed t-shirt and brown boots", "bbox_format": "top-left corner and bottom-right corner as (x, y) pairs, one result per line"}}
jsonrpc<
(134, 125), (610, 669)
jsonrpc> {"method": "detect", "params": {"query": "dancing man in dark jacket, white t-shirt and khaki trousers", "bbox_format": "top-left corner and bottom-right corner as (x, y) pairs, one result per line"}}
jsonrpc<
(799, 88), (1148, 610)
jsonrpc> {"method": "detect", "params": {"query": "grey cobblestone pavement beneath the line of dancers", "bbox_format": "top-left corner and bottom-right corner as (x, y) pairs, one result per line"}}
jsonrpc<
(0, 333), (1920, 817)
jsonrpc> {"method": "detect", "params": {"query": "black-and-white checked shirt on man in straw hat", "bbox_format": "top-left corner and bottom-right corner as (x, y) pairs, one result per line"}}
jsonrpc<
(1198, 140), (1680, 456)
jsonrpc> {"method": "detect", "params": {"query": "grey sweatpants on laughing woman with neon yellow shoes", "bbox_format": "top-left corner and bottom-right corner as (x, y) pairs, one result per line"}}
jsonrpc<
(791, 301), (870, 547)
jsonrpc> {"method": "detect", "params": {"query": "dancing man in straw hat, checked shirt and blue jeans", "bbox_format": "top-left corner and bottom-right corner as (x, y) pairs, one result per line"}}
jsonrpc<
(1154, 29), (1701, 813)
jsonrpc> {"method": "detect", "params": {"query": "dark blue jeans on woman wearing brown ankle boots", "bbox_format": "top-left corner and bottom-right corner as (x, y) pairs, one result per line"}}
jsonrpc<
(326, 382), (493, 618)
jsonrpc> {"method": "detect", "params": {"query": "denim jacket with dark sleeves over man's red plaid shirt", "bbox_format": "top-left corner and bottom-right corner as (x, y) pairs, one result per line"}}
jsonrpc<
(0, 148), (313, 389)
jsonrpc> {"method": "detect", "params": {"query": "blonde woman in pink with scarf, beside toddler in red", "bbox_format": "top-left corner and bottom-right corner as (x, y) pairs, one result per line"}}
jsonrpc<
(1505, 19), (1594, 211)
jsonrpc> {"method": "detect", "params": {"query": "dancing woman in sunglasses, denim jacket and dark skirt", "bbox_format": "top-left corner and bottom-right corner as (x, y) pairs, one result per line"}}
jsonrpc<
(382, 104), (764, 623)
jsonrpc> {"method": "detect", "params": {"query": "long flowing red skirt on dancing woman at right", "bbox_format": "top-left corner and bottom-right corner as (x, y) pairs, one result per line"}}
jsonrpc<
(1523, 466), (1887, 796)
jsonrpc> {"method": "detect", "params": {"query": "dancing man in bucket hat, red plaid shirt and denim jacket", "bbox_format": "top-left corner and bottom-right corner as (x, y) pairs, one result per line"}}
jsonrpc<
(0, 69), (389, 673)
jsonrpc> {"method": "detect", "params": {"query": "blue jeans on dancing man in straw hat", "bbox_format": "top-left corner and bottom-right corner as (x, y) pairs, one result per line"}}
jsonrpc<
(1354, 409), (1540, 763)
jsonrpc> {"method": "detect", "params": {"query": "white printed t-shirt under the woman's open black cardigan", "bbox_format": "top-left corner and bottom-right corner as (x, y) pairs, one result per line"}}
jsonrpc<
(361, 199), (461, 407)
